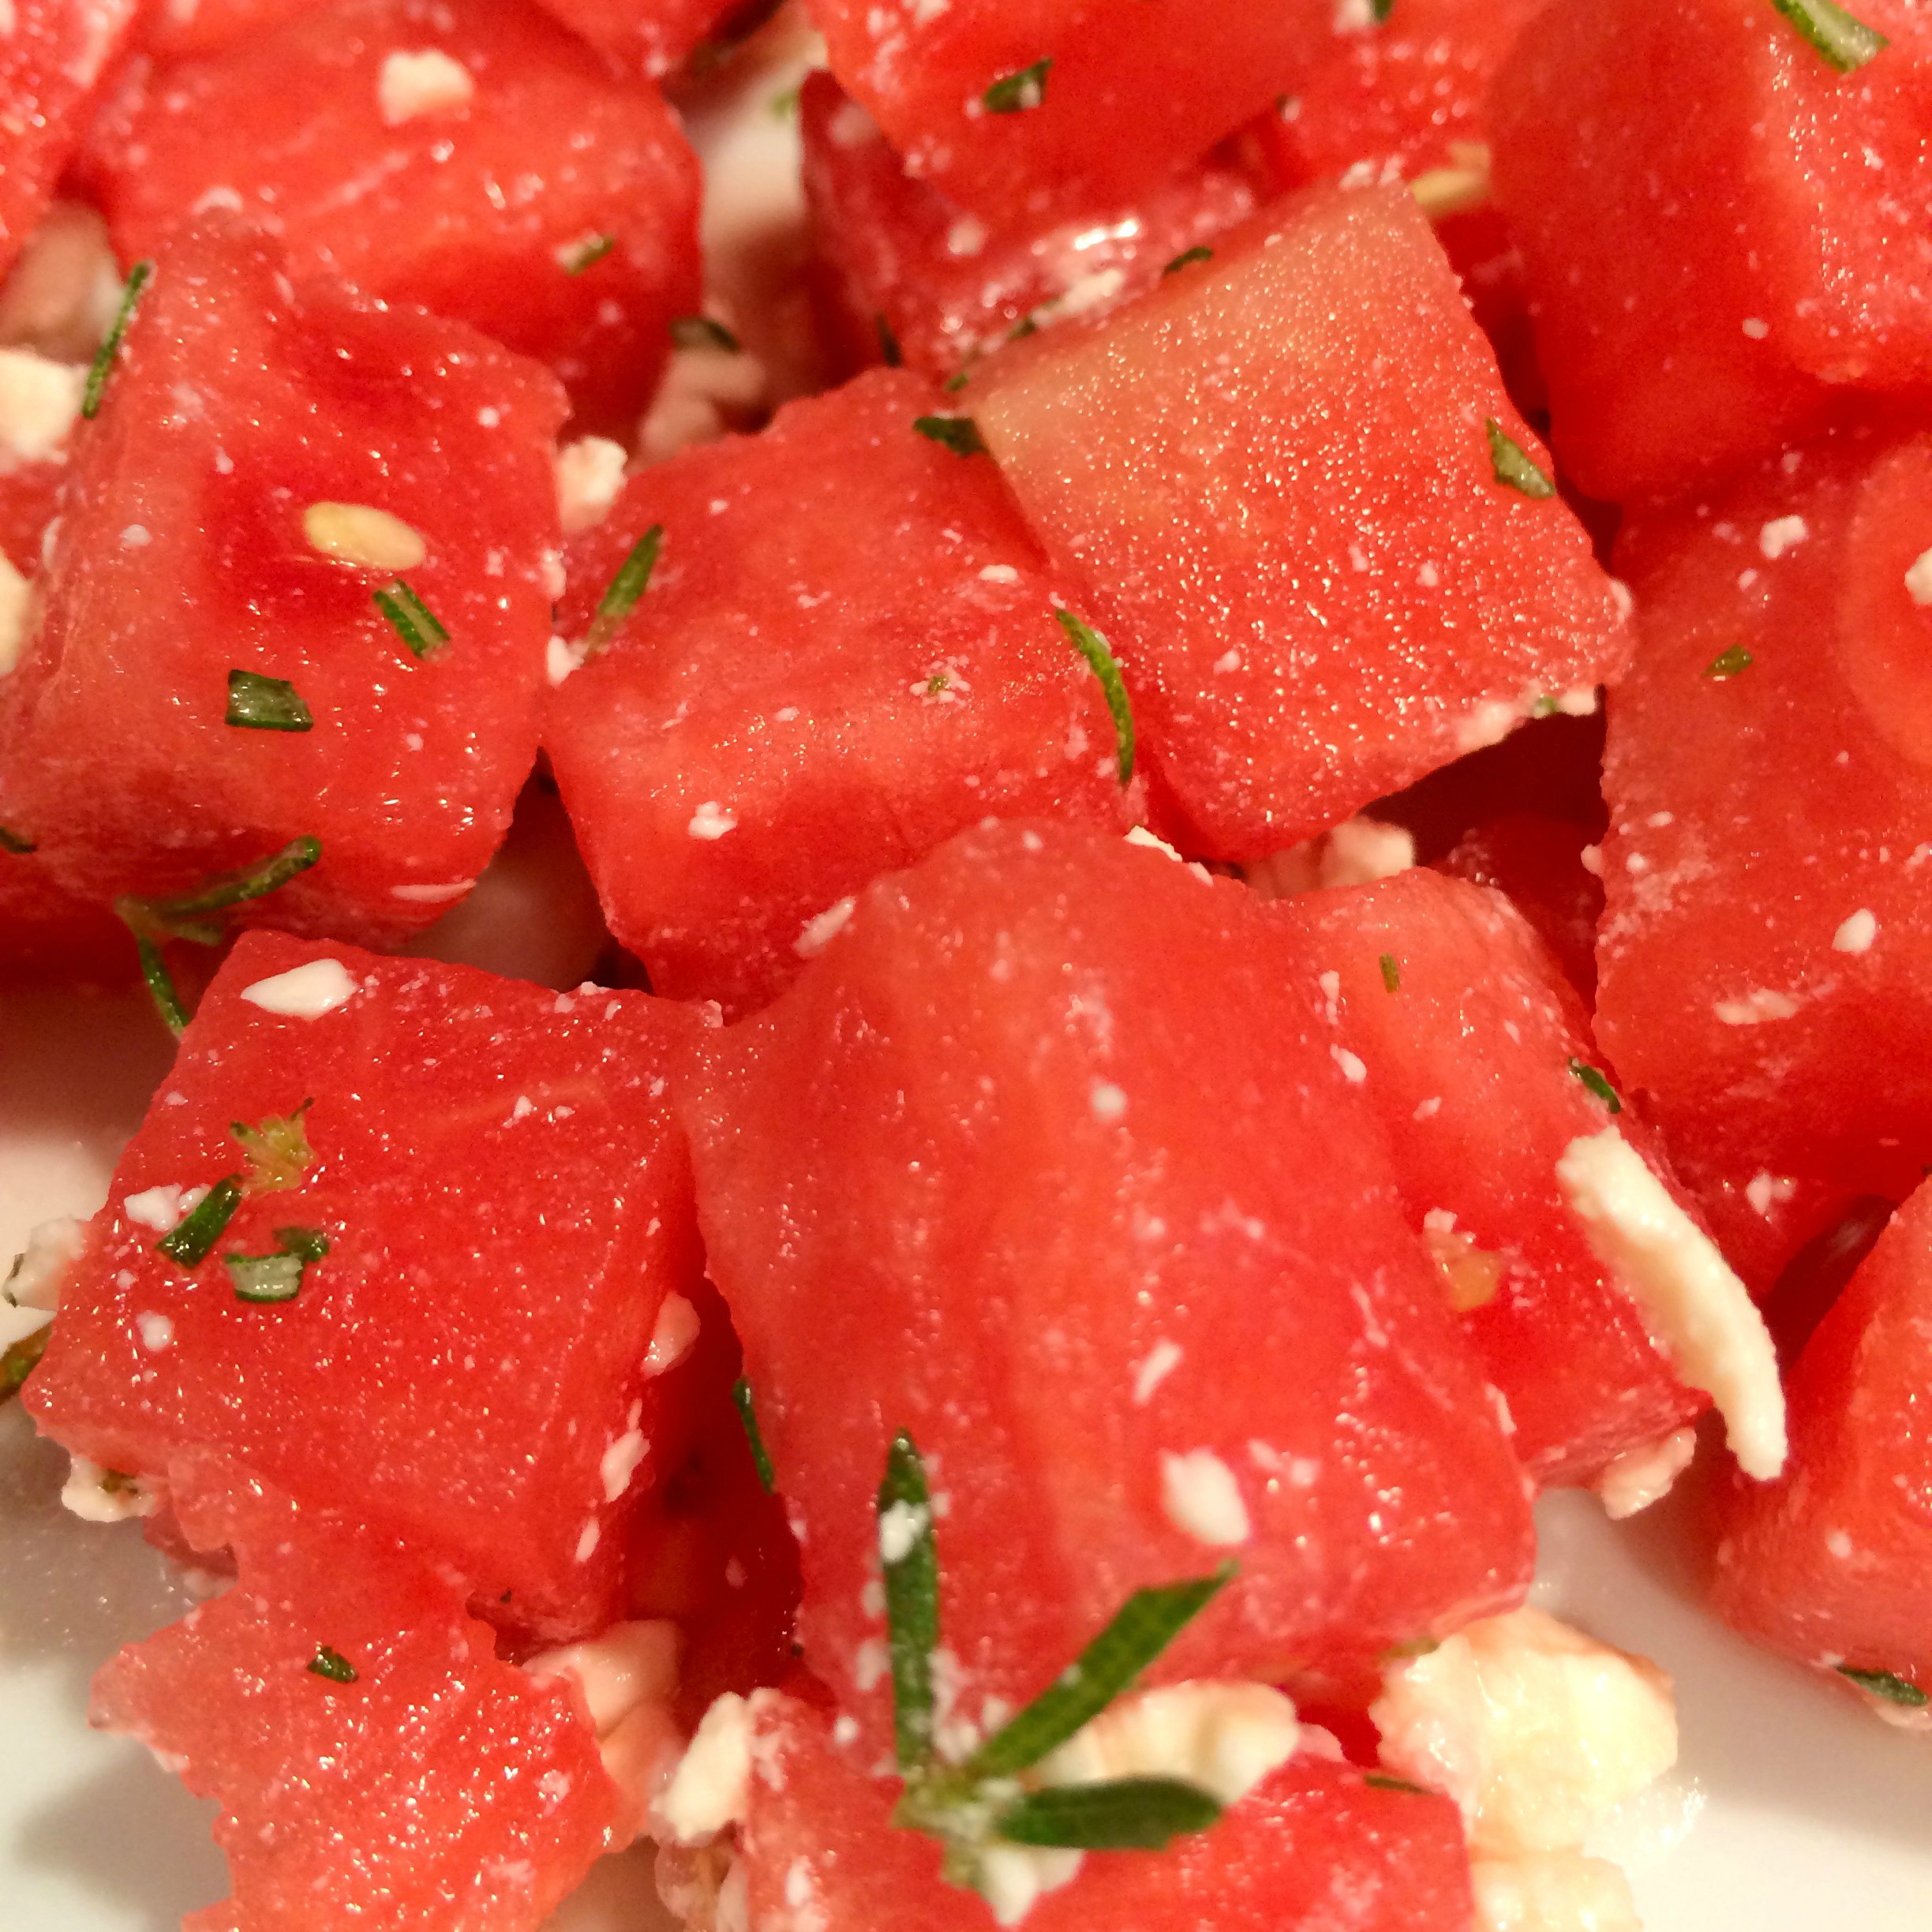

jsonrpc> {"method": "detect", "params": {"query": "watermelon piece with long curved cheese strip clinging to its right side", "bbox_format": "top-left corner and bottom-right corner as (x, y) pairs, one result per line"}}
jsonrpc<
(1273, 870), (1704, 1484)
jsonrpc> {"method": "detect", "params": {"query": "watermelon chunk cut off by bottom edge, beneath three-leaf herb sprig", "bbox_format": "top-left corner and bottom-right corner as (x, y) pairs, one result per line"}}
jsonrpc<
(703, 1698), (1472, 1932)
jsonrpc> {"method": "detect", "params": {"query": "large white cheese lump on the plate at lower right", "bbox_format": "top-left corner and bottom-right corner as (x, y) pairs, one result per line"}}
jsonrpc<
(1370, 1609), (1677, 1857)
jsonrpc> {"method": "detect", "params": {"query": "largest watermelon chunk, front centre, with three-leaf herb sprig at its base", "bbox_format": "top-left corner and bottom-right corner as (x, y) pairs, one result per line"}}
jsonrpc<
(684, 823), (1530, 1748)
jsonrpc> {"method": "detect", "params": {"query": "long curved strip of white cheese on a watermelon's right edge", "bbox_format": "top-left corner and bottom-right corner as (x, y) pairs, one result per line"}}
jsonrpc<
(1557, 1126), (1785, 1480)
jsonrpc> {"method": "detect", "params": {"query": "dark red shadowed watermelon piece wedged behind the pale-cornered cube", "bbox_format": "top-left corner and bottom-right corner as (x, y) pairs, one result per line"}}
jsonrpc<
(798, 73), (1256, 376)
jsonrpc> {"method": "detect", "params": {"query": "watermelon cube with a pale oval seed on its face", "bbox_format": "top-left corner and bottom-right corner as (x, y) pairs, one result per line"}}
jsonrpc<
(0, 230), (564, 941)
